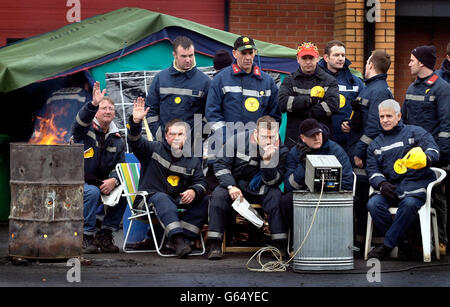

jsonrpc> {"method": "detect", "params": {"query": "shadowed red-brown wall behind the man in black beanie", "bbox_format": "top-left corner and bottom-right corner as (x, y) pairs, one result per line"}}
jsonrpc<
(395, 18), (450, 103)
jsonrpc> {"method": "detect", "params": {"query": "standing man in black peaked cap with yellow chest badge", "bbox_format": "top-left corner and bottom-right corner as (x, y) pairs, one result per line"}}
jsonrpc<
(206, 36), (281, 189)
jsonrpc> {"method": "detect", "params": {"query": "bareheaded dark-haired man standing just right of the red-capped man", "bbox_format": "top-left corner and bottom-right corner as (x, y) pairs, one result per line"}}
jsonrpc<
(319, 40), (365, 148)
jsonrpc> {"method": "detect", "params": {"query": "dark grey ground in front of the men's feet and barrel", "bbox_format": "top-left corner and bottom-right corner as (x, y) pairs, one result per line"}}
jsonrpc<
(0, 224), (450, 290)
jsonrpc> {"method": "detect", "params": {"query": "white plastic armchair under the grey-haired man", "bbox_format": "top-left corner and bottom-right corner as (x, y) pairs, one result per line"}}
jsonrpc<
(364, 167), (447, 262)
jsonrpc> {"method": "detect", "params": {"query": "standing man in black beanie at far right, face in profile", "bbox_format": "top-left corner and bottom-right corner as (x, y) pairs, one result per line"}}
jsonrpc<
(402, 46), (450, 255)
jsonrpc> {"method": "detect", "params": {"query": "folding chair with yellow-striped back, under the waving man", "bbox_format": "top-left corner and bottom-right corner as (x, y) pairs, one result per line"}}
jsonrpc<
(116, 163), (206, 257)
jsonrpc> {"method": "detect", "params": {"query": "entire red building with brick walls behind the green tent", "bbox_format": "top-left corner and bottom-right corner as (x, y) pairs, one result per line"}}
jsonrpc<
(0, 0), (450, 102)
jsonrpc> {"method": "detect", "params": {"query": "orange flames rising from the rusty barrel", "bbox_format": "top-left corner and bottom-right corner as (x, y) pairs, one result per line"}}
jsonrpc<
(29, 114), (67, 145)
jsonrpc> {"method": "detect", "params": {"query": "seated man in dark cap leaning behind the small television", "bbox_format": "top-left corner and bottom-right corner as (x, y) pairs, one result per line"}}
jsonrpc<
(281, 118), (353, 233)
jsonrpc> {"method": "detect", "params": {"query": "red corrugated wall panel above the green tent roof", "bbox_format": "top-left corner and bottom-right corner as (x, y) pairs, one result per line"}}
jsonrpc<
(0, 0), (224, 46)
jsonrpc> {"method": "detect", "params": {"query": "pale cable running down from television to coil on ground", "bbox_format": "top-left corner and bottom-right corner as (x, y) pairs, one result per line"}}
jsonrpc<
(246, 174), (325, 272)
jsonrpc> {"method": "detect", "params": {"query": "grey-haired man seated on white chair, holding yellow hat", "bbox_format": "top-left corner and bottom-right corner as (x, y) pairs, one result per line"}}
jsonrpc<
(367, 99), (439, 260)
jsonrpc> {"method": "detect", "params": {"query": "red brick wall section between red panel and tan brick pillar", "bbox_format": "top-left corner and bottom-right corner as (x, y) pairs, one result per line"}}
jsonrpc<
(230, 0), (334, 53)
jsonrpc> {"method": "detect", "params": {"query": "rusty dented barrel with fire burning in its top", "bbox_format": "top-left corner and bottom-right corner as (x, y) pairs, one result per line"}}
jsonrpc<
(8, 143), (84, 259)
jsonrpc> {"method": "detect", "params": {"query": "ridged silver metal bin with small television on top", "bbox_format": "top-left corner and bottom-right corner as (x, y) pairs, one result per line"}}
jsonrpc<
(293, 191), (354, 272)
